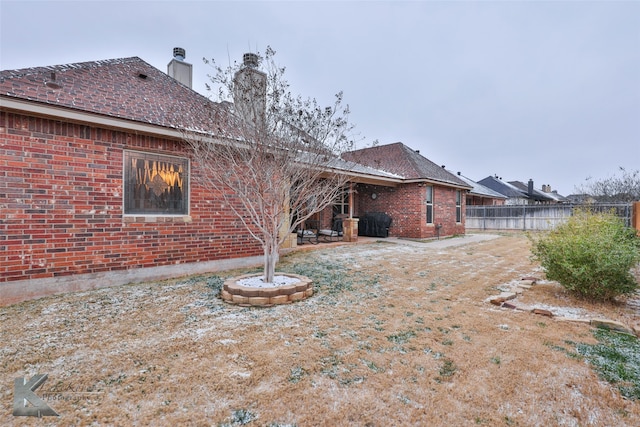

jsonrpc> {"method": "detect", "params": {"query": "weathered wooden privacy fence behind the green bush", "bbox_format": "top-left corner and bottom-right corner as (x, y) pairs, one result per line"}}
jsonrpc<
(466, 203), (640, 230)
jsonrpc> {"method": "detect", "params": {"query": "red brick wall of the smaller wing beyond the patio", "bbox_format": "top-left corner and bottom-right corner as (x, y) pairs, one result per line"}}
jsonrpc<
(355, 184), (465, 239)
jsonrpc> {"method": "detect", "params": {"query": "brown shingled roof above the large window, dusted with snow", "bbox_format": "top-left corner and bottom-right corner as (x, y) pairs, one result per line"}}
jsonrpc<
(0, 57), (225, 128)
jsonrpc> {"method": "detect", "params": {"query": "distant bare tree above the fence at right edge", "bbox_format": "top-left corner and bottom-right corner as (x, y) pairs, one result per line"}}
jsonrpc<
(576, 167), (640, 202)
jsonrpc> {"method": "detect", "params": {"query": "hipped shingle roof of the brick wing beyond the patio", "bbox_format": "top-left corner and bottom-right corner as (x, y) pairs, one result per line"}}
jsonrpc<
(342, 142), (472, 189)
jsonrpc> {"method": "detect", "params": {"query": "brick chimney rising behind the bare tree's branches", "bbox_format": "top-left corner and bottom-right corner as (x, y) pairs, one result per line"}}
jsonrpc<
(233, 53), (267, 130)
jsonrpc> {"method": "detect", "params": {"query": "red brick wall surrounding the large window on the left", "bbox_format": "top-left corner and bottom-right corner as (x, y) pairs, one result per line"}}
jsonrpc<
(0, 112), (262, 282)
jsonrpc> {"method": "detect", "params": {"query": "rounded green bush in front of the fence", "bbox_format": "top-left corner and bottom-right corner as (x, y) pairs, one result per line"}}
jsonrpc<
(531, 209), (640, 301)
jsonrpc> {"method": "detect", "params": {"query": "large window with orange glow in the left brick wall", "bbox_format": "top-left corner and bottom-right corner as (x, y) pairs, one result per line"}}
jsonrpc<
(124, 151), (189, 215)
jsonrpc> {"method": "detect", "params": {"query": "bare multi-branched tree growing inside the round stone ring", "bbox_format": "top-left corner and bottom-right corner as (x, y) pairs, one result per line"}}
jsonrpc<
(185, 48), (353, 282)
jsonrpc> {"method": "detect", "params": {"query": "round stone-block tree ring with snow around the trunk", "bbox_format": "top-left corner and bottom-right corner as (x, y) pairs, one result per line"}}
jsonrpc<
(221, 273), (313, 307)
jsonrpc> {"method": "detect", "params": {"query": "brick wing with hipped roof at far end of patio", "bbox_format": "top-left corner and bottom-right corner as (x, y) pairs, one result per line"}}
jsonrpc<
(342, 142), (472, 239)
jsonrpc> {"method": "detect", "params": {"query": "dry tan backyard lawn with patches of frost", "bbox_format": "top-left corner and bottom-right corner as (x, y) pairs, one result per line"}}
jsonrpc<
(0, 235), (640, 426)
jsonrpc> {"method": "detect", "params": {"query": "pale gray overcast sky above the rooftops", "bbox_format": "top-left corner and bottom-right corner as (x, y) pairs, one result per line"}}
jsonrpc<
(0, 0), (640, 195)
